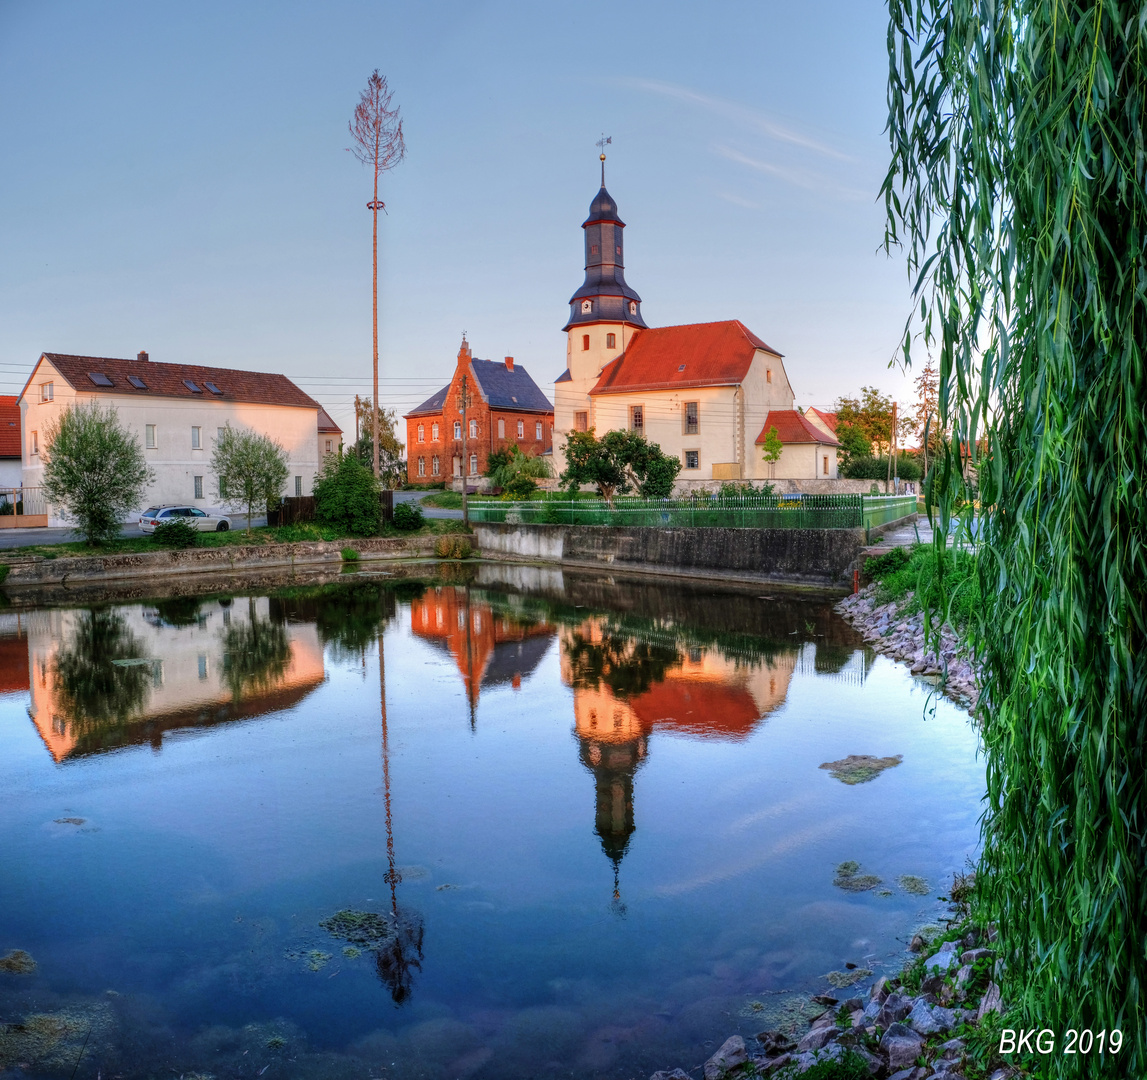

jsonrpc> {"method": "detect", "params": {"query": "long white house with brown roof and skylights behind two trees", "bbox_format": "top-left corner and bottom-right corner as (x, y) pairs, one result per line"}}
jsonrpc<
(18, 352), (341, 525)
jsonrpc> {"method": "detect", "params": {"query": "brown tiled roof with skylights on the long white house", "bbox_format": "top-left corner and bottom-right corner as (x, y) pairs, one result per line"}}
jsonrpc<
(27, 352), (320, 409)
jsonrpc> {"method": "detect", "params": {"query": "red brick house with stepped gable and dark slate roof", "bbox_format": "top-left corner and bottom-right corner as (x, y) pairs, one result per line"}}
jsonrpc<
(403, 337), (554, 484)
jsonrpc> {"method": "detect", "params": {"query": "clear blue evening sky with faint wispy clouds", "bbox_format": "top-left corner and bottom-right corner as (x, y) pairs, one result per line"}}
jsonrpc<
(0, 0), (912, 428)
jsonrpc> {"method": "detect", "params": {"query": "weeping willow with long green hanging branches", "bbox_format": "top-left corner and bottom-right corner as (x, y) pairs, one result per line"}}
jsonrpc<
(883, 0), (1147, 1077)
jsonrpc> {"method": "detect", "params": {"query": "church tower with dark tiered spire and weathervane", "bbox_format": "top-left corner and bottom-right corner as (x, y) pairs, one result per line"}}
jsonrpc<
(554, 154), (646, 469)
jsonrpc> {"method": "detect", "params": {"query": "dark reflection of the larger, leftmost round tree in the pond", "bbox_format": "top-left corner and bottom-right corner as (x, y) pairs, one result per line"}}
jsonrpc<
(52, 608), (151, 736)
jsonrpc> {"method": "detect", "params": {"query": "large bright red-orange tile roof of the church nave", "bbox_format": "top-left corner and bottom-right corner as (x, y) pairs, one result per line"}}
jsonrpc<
(590, 319), (780, 394)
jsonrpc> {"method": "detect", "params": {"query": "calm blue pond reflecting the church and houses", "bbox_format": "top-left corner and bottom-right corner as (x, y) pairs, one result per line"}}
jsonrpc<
(0, 563), (984, 1080)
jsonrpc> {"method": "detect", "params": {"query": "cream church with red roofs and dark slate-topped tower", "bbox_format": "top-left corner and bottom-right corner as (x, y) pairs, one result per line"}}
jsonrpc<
(554, 162), (840, 490)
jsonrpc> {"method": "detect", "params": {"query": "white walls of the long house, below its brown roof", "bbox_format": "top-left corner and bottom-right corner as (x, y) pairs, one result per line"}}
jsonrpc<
(19, 359), (320, 525)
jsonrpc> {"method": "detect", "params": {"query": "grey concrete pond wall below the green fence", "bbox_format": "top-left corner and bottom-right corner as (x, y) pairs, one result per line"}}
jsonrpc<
(473, 524), (880, 588)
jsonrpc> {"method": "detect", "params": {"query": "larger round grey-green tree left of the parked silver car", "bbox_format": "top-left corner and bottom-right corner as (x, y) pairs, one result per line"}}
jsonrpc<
(42, 401), (155, 543)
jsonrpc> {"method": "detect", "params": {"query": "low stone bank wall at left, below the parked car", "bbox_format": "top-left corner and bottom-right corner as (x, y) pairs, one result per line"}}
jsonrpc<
(3, 535), (437, 590)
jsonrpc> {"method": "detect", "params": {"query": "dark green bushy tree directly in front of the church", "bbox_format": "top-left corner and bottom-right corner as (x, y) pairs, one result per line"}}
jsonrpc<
(560, 428), (681, 506)
